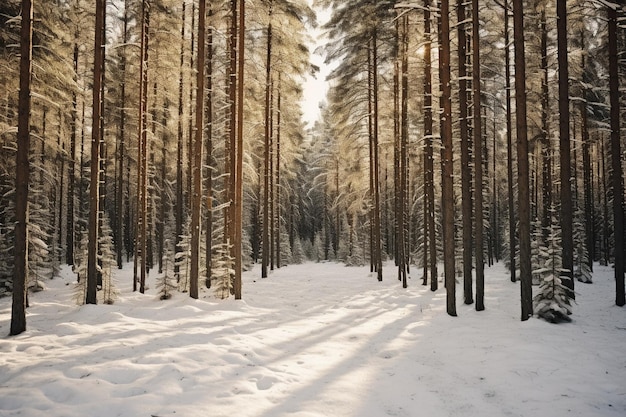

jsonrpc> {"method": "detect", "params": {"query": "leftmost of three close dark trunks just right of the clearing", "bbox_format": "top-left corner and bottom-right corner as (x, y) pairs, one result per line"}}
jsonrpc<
(439, 0), (456, 316)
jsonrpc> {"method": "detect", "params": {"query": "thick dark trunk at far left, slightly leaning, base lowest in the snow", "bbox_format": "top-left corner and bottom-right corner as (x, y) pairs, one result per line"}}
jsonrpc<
(9, 0), (33, 336)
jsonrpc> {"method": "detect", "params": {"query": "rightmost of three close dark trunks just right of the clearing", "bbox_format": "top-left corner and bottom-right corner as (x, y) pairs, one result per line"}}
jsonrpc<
(472, 0), (486, 311)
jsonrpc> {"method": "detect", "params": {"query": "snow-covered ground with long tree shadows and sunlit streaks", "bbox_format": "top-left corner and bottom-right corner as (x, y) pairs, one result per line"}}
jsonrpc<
(0, 263), (626, 417)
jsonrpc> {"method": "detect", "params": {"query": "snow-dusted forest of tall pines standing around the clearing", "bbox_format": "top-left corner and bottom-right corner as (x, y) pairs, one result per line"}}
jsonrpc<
(0, 0), (626, 334)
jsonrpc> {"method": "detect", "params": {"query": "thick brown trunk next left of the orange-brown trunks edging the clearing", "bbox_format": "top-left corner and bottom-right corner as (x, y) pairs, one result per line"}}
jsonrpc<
(189, 0), (206, 299)
